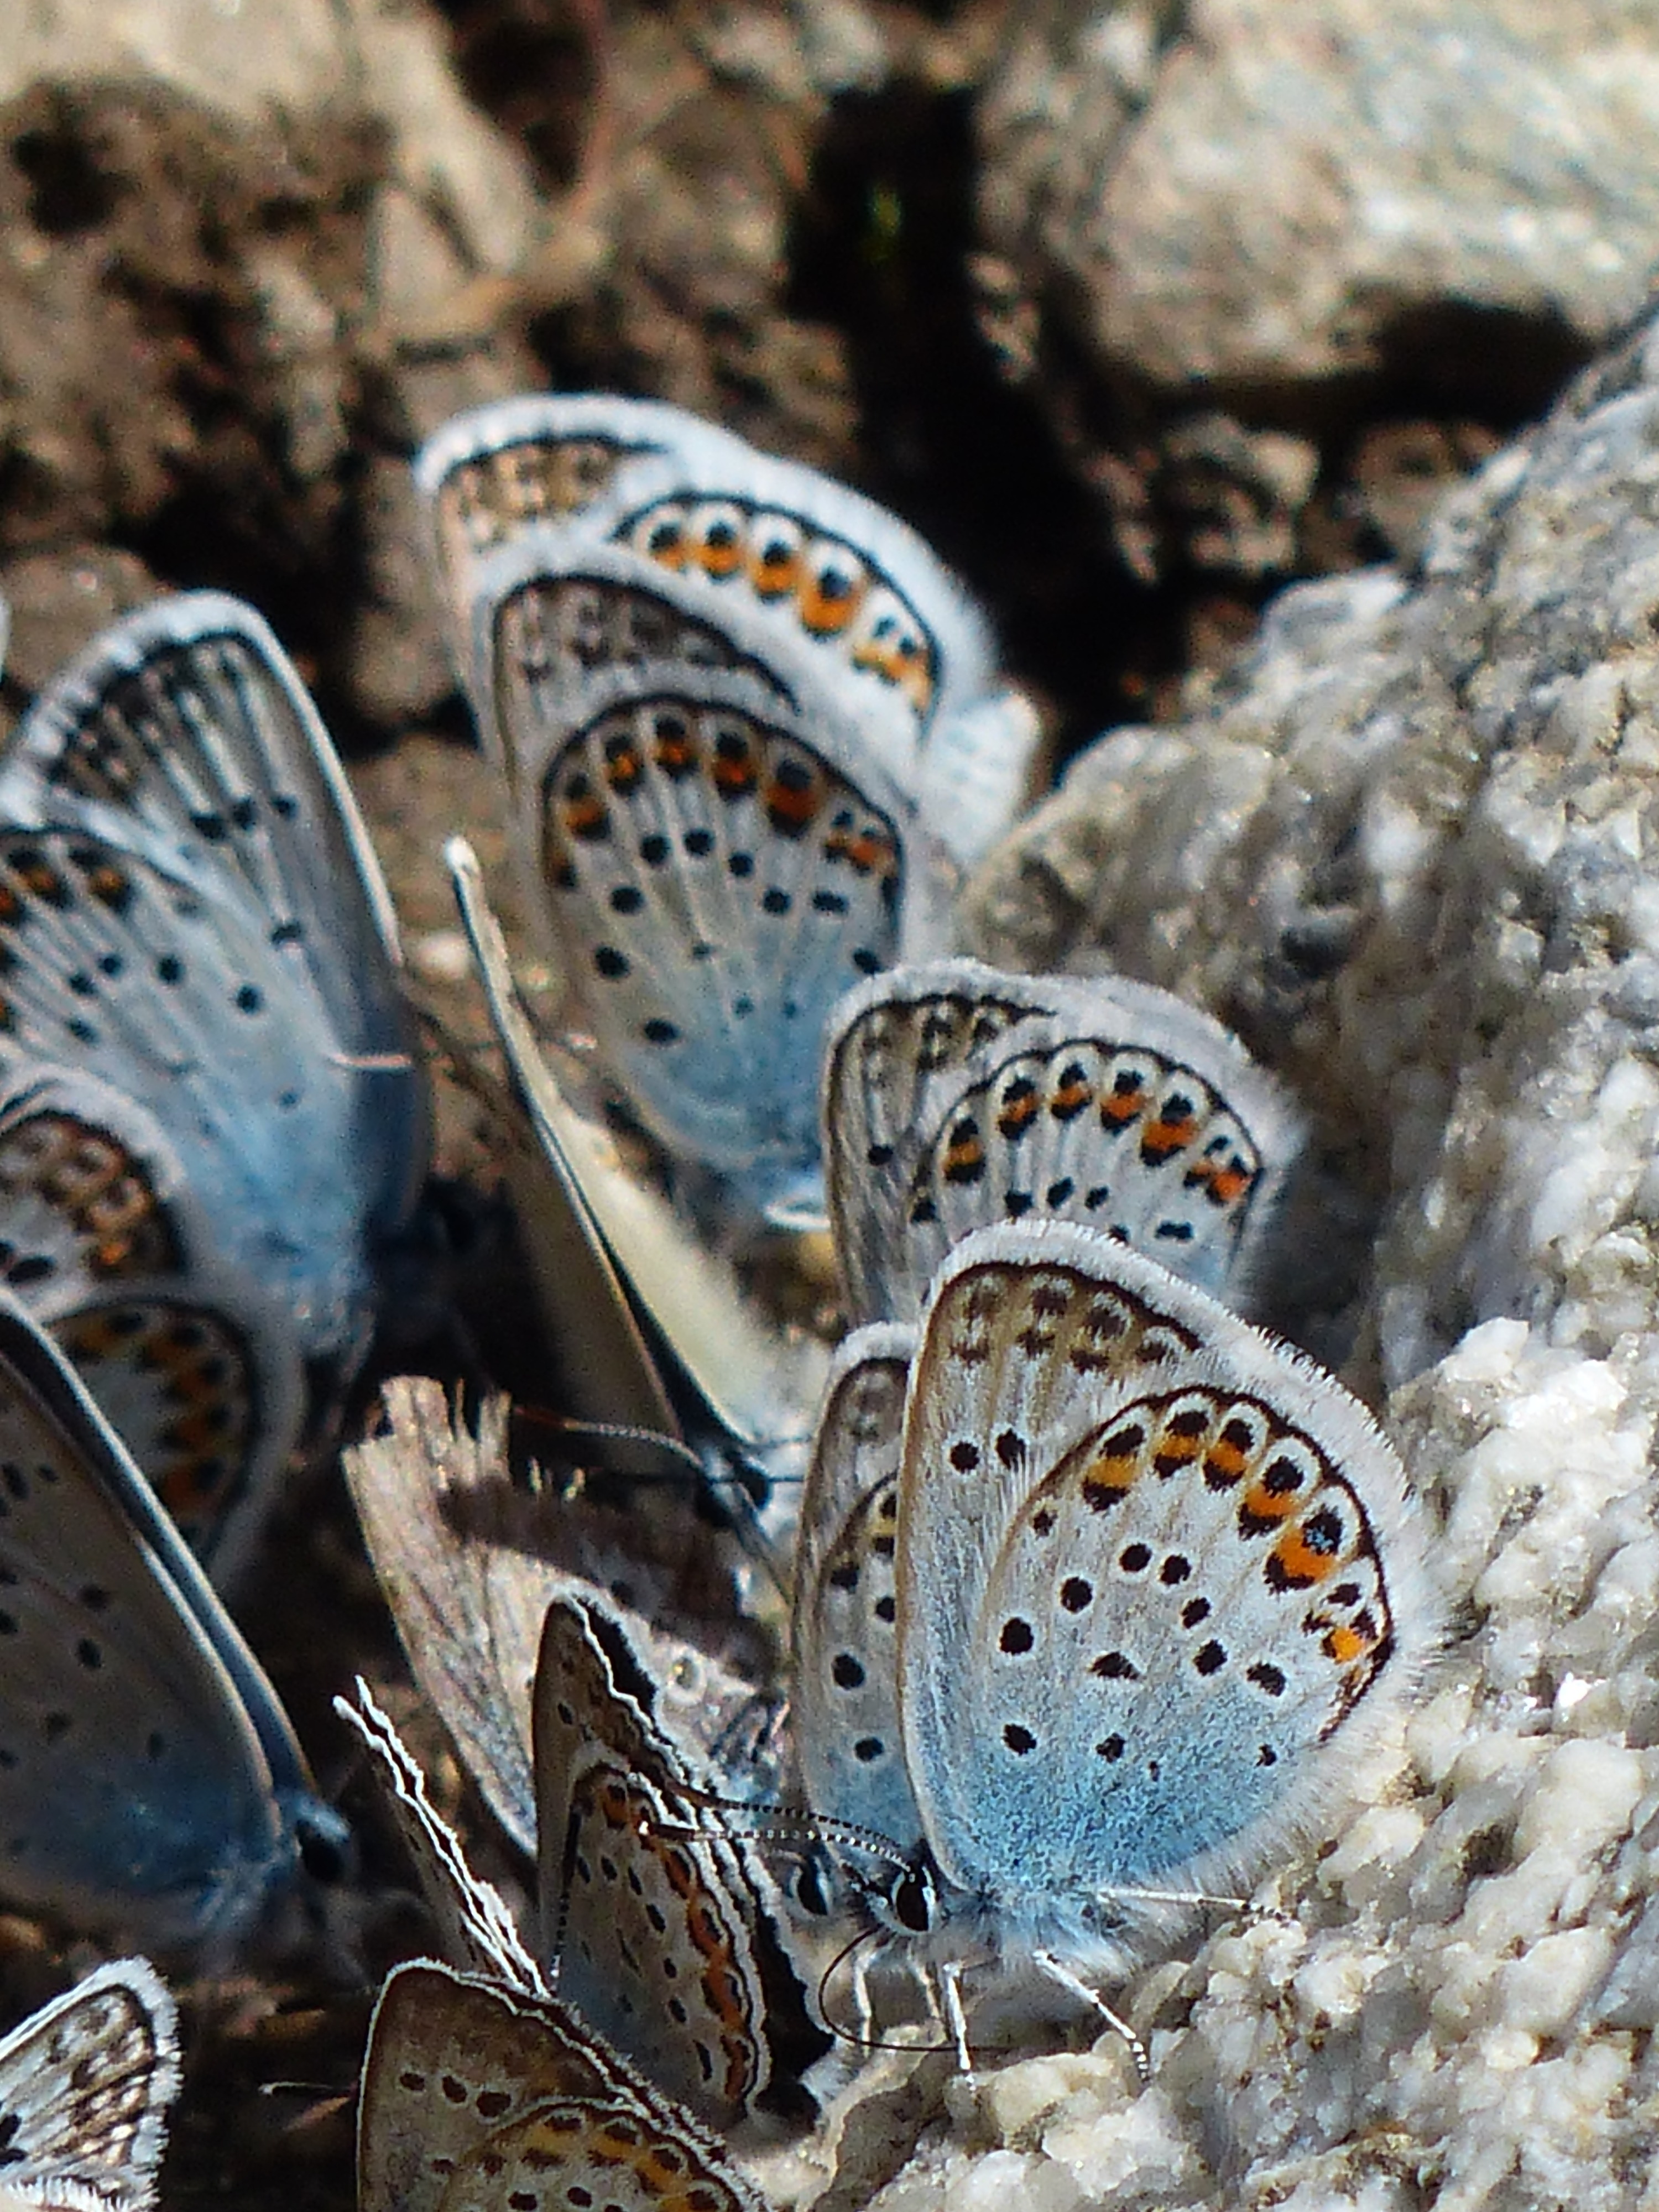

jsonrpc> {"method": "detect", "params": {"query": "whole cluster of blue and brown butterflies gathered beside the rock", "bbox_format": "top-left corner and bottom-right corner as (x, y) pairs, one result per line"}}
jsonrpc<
(0, 396), (1431, 2212)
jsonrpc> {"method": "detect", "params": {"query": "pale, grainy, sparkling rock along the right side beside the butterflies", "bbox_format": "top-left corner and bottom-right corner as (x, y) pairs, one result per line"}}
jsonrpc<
(947, 307), (1659, 2212)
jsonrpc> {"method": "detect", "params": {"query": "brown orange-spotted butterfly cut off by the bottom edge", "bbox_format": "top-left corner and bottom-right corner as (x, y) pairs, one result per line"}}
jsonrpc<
(356, 1960), (765, 2212)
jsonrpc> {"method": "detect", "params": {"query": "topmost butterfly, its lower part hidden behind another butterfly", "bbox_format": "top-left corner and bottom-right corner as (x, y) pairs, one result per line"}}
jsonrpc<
(416, 394), (1037, 865)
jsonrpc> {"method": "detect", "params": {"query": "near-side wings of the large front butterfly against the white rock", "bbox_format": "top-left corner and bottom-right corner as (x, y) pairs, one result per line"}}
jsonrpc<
(898, 1223), (1427, 1940)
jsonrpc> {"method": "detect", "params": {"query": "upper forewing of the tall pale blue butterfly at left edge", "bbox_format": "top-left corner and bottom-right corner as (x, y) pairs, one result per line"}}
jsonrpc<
(0, 593), (427, 1232)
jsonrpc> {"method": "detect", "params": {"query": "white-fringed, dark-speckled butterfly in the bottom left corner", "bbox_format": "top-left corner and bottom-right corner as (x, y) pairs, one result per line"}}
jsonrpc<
(0, 1958), (179, 2212)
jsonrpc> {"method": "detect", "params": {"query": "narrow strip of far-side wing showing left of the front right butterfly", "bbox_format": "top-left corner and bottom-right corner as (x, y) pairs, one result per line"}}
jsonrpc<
(790, 1323), (922, 1854)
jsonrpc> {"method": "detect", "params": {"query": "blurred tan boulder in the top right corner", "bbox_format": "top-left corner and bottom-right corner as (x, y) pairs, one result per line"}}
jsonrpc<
(980, 0), (1659, 575)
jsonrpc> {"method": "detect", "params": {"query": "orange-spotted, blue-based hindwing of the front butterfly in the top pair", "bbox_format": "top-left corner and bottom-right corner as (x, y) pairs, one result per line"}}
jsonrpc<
(471, 646), (933, 1208)
